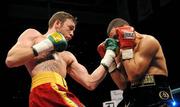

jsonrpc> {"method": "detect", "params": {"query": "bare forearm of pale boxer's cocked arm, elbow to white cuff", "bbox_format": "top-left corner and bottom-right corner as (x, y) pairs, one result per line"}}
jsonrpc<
(6, 47), (34, 67)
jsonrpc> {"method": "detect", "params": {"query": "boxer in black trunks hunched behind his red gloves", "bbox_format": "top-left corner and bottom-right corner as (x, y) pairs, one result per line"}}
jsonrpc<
(98, 18), (173, 107)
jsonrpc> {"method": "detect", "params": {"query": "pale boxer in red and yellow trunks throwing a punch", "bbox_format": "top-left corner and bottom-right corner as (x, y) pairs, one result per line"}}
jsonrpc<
(6, 11), (118, 107)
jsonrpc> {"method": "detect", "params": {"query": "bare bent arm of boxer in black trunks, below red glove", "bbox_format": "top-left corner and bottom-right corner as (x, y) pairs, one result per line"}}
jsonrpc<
(123, 37), (159, 81)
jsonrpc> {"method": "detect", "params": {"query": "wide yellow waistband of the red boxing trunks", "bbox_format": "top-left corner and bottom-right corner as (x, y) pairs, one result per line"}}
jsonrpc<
(31, 71), (68, 90)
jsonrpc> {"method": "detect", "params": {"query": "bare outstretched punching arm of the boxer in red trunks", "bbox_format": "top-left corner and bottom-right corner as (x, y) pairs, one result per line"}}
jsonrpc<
(68, 52), (107, 90)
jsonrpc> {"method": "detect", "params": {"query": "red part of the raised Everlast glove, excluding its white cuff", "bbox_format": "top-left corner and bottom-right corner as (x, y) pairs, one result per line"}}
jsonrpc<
(116, 26), (135, 49)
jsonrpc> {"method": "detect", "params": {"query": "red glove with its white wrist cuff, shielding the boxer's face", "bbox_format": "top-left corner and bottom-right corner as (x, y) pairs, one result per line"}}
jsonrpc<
(116, 26), (135, 60)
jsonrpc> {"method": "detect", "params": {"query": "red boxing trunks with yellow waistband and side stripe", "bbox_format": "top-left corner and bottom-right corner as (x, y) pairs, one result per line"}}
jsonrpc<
(29, 71), (85, 107)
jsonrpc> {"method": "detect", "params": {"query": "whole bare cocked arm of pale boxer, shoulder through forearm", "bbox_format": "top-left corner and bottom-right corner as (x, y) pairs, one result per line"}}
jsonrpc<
(6, 29), (40, 67)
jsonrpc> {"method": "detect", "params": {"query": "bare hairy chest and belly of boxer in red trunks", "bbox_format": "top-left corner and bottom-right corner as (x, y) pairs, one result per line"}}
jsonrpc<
(25, 35), (71, 77)
